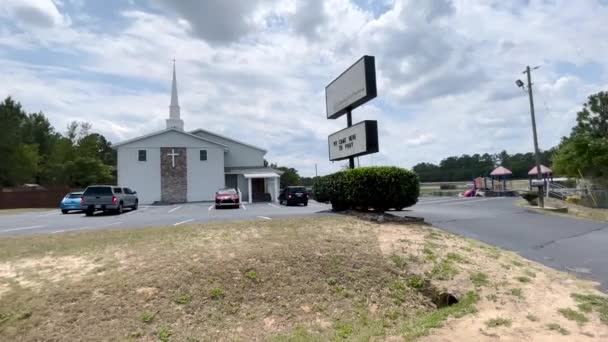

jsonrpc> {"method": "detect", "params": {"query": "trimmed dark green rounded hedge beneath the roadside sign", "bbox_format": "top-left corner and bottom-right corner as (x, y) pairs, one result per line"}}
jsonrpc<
(313, 166), (420, 211)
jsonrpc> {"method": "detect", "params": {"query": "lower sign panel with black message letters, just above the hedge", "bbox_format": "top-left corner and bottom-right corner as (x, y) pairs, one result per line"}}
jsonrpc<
(328, 120), (378, 160)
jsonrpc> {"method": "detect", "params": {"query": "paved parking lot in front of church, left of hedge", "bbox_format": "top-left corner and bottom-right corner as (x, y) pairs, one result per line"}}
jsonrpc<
(0, 200), (330, 236)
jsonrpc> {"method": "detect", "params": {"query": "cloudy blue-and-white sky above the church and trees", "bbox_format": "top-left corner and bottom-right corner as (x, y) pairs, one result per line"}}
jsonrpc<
(0, 0), (608, 175)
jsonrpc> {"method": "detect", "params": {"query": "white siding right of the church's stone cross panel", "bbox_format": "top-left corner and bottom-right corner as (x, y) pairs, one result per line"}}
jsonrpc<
(187, 148), (225, 202)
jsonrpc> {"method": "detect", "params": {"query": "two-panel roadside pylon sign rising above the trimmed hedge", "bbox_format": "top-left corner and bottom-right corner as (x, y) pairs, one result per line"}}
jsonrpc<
(325, 56), (379, 169)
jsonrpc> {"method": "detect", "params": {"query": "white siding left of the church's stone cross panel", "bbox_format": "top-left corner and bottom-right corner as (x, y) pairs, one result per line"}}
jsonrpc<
(117, 147), (160, 204)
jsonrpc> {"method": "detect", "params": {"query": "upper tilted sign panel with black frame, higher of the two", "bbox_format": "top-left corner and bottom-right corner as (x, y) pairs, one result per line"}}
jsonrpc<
(325, 56), (376, 119)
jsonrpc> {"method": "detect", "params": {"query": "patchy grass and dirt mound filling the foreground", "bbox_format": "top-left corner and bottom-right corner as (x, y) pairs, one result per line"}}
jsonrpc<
(0, 216), (608, 341)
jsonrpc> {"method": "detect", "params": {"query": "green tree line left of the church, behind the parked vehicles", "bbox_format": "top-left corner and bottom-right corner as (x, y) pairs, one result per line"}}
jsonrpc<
(0, 97), (116, 187)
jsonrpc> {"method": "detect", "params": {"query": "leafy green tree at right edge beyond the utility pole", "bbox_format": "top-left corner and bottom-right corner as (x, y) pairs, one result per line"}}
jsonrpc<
(554, 92), (608, 183)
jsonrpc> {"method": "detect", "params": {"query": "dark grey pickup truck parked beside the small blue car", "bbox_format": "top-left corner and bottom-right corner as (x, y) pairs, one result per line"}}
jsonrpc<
(80, 185), (139, 216)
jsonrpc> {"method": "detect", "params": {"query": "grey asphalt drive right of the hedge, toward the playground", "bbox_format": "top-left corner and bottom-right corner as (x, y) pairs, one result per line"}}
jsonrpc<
(405, 197), (608, 291)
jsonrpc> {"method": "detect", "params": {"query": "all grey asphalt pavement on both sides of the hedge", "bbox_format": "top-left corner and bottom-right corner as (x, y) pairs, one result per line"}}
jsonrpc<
(0, 197), (608, 291)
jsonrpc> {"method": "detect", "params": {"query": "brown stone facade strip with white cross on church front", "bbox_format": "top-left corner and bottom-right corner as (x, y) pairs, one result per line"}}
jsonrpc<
(160, 147), (188, 203)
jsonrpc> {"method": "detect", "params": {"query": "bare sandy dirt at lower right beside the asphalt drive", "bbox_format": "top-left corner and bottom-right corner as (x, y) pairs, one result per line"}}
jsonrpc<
(378, 220), (608, 341)
